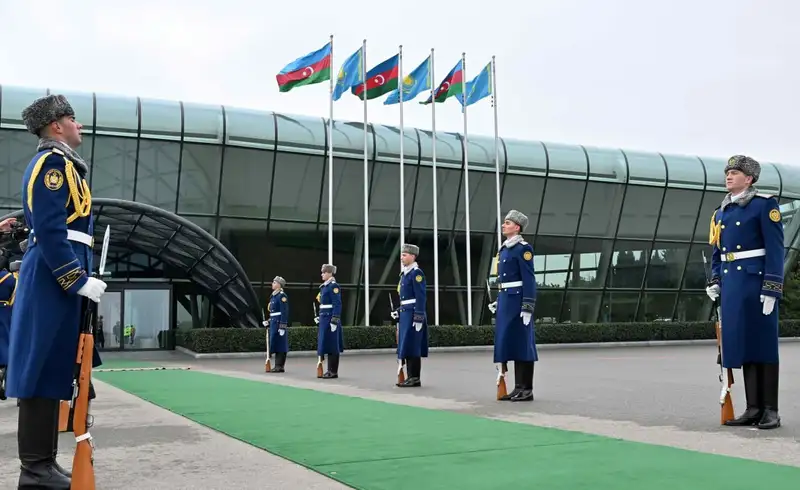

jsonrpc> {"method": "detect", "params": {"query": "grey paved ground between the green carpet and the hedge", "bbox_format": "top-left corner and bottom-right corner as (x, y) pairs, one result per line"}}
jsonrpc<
(117, 343), (800, 466)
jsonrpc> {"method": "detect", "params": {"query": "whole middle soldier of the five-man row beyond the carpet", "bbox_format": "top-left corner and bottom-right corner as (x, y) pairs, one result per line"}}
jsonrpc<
(392, 243), (428, 388)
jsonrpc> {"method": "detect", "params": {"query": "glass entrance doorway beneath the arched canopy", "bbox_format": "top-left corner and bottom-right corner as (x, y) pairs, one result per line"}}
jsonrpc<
(95, 282), (172, 351)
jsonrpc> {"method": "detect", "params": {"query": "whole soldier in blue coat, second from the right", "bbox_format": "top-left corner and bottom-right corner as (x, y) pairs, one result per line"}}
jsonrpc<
(489, 209), (539, 402)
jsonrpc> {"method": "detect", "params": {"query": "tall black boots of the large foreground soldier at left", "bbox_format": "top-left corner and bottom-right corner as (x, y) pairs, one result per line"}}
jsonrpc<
(17, 398), (70, 490)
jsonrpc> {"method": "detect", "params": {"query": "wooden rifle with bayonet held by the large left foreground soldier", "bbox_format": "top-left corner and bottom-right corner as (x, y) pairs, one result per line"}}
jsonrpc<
(68, 226), (111, 490)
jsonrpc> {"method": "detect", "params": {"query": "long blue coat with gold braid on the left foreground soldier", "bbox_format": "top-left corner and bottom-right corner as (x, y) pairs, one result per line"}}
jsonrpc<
(6, 149), (99, 400)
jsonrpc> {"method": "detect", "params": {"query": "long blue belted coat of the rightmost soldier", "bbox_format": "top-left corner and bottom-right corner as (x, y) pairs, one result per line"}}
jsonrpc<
(709, 194), (784, 368)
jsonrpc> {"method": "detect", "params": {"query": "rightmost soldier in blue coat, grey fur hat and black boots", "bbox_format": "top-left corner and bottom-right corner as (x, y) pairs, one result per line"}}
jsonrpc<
(706, 155), (784, 429)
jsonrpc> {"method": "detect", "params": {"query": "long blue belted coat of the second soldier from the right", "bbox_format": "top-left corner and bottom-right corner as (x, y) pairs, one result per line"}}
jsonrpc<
(494, 240), (539, 362)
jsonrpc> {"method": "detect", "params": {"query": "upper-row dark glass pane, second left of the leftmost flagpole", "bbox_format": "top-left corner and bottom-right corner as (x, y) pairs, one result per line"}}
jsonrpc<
(219, 146), (274, 218)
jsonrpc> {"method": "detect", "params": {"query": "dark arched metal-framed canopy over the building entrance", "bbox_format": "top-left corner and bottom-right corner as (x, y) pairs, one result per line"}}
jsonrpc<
(0, 198), (261, 328)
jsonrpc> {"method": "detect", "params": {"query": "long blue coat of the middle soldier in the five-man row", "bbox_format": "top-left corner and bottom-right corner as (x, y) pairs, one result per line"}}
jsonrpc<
(397, 267), (428, 359)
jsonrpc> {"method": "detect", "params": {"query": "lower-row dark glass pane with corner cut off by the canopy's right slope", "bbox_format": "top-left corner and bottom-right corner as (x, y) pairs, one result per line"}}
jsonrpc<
(219, 218), (274, 282)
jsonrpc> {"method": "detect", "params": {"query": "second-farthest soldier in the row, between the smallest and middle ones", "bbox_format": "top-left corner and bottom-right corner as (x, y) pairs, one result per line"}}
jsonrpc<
(314, 264), (344, 379)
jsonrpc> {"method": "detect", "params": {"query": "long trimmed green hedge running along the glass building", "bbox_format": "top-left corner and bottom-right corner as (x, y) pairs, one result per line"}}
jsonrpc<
(176, 320), (800, 354)
